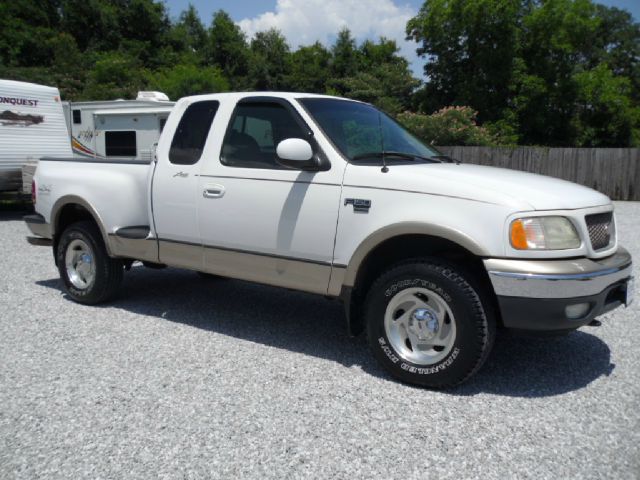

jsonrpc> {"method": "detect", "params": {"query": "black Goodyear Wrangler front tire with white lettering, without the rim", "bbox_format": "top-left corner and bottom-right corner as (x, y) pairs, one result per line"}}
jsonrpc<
(364, 258), (496, 389)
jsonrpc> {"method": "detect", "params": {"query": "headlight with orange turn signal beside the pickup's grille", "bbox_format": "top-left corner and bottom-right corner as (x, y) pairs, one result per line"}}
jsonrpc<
(509, 217), (580, 250)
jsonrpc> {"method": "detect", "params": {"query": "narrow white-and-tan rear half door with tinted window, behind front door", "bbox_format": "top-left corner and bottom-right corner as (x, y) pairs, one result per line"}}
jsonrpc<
(152, 100), (219, 270)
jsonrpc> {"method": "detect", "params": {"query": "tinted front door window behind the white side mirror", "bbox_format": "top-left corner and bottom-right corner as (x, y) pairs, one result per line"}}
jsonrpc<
(220, 102), (306, 169)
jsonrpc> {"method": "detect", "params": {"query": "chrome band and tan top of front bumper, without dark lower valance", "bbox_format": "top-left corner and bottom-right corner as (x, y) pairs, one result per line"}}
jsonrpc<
(484, 248), (632, 298)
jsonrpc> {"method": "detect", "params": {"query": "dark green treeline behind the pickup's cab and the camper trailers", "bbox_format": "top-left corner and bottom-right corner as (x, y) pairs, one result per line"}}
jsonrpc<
(0, 0), (419, 113)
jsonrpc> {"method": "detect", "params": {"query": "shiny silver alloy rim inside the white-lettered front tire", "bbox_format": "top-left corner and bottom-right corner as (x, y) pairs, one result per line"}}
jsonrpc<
(384, 288), (456, 365)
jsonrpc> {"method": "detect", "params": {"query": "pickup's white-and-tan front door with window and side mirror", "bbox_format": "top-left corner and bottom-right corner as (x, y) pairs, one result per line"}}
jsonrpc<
(198, 97), (343, 293)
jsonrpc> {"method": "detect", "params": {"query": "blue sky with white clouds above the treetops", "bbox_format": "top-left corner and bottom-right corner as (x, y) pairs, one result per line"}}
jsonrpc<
(165, 0), (640, 77)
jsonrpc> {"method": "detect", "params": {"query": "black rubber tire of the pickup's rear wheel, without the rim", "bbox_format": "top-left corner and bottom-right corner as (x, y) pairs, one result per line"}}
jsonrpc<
(56, 221), (124, 305)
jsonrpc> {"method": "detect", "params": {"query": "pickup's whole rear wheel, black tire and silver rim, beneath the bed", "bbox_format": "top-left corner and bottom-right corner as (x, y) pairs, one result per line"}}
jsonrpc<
(56, 221), (123, 304)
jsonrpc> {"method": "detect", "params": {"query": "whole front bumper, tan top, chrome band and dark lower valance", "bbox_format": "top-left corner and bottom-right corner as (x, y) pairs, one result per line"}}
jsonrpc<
(484, 248), (632, 331)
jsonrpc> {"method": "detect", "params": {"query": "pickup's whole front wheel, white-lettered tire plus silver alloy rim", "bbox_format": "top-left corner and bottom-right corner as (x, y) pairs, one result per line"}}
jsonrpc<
(365, 259), (495, 388)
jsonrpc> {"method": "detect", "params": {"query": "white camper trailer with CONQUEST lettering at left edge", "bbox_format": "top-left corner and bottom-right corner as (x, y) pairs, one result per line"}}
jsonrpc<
(0, 80), (71, 191)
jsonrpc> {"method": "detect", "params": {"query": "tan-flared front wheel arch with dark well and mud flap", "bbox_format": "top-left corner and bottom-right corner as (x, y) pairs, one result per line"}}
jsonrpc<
(339, 222), (495, 335)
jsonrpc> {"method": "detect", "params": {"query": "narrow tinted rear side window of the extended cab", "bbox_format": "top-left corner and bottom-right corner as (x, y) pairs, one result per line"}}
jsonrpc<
(169, 101), (220, 165)
